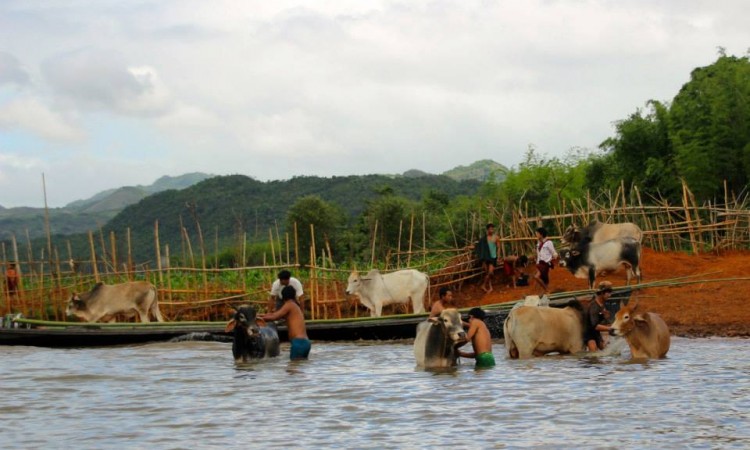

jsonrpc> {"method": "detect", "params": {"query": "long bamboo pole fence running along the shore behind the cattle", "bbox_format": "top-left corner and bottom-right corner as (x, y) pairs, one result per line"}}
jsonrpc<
(0, 183), (750, 321)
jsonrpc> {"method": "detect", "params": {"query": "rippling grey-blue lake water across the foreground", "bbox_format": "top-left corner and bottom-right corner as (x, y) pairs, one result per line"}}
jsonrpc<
(0, 338), (750, 449)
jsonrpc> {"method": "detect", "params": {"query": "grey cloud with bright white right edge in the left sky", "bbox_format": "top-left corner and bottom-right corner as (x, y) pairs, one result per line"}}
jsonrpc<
(41, 49), (172, 117)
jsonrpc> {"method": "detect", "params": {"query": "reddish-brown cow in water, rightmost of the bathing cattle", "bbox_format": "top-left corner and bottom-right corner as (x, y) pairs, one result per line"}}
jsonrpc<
(609, 300), (669, 359)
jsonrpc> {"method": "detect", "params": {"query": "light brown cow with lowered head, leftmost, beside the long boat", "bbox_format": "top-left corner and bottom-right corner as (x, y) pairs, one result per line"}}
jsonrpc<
(65, 281), (164, 323)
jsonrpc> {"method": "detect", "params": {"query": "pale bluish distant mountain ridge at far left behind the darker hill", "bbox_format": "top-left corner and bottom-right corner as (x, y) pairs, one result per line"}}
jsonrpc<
(0, 173), (213, 241)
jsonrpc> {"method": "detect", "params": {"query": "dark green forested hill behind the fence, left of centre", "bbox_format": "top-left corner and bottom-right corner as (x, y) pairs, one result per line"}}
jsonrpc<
(65, 175), (481, 261)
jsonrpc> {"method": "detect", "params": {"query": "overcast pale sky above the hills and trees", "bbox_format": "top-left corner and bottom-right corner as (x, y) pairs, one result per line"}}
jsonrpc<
(0, 0), (750, 207)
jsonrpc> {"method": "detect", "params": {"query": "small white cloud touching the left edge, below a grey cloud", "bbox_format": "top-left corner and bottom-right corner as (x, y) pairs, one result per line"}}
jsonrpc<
(0, 98), (85, 141)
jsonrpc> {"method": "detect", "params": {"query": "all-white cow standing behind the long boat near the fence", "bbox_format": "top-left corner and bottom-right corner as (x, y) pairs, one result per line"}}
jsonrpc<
(346, 269), (430, 317)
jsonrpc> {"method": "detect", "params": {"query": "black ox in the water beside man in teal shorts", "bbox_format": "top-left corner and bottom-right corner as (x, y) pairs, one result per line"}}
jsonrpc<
(224, 305), (279, 363)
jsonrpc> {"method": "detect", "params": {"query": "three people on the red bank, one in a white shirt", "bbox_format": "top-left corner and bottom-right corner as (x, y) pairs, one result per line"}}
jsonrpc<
(475, 223), (559, 294)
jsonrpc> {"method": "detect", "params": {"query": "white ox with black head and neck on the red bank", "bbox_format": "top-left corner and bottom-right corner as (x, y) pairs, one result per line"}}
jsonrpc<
(560, 238), (641, 289)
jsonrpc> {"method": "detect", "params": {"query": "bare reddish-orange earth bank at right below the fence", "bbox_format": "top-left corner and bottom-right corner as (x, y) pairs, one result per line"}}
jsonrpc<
(456, 249), (750, 337)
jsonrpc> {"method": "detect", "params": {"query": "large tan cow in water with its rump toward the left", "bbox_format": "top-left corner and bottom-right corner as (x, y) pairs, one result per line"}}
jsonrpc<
(503, 300), (585, 359)
